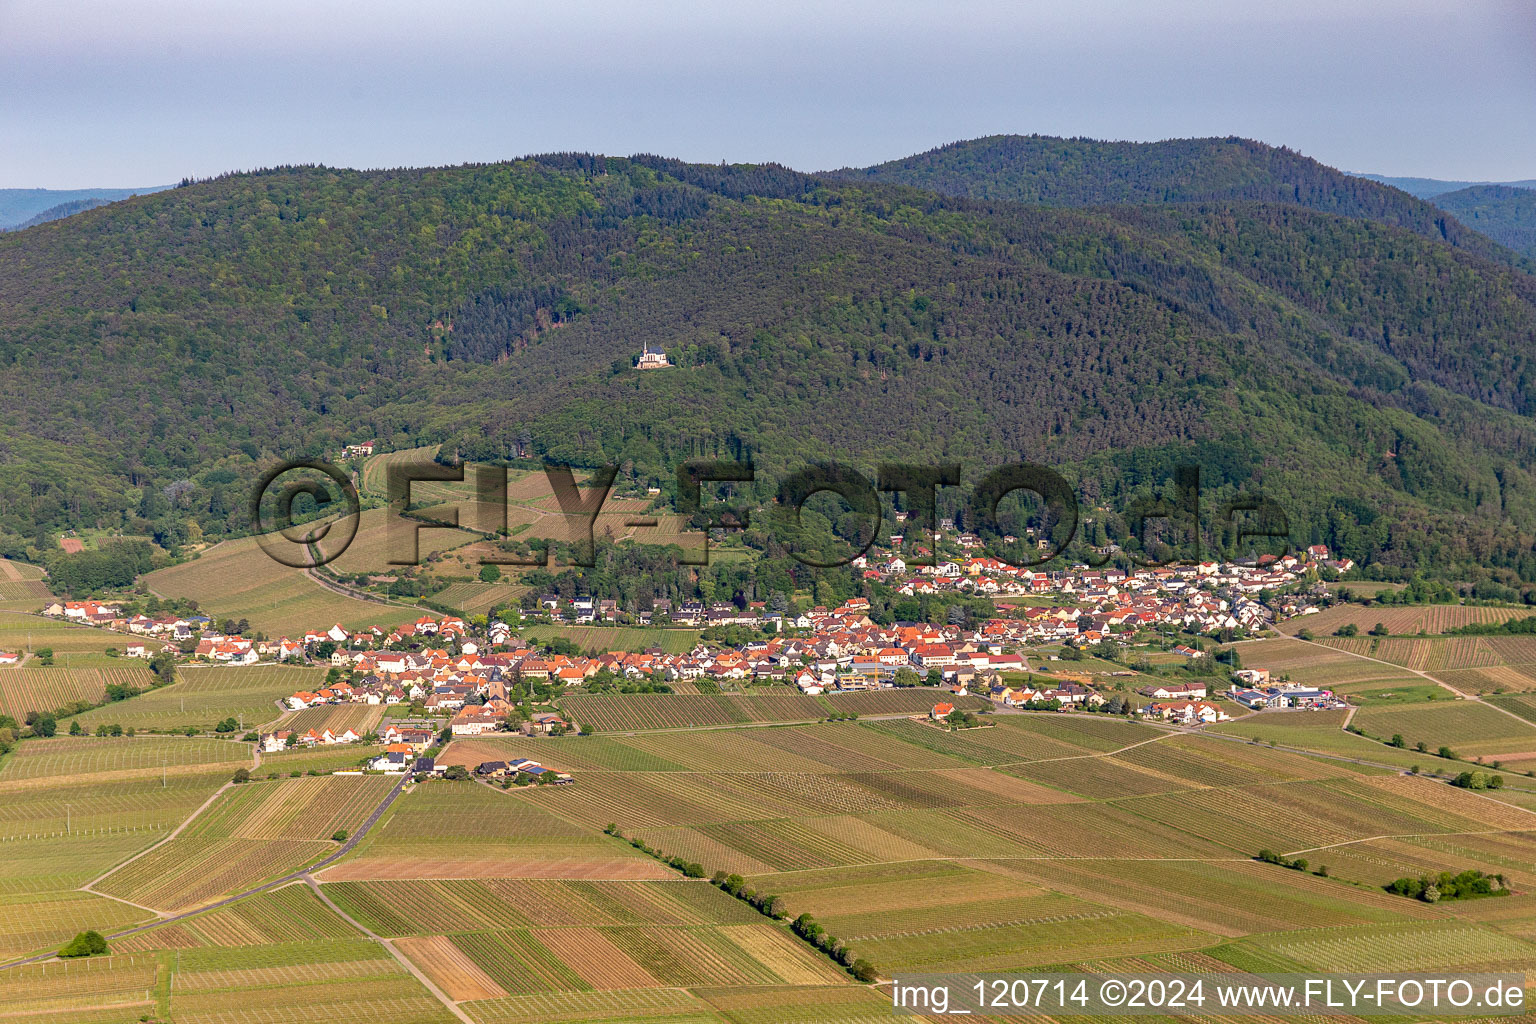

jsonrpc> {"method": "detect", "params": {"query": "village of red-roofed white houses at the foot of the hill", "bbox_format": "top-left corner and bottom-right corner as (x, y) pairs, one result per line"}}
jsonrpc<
(24, 534), (1349, 781)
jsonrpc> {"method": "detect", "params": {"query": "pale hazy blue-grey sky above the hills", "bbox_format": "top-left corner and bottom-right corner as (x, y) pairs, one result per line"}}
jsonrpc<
(0, 0), (1536, 187)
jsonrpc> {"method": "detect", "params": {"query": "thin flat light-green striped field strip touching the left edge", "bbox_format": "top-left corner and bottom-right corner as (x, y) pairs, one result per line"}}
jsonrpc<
(0, 735), (252, 781)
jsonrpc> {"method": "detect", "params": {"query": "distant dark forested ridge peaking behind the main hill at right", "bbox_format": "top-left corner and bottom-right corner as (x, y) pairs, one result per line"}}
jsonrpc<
(831, 135), (1502, 258)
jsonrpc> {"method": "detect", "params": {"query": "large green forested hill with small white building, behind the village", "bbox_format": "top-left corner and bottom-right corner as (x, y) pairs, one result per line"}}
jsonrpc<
(0, 148), (1536, 580)
